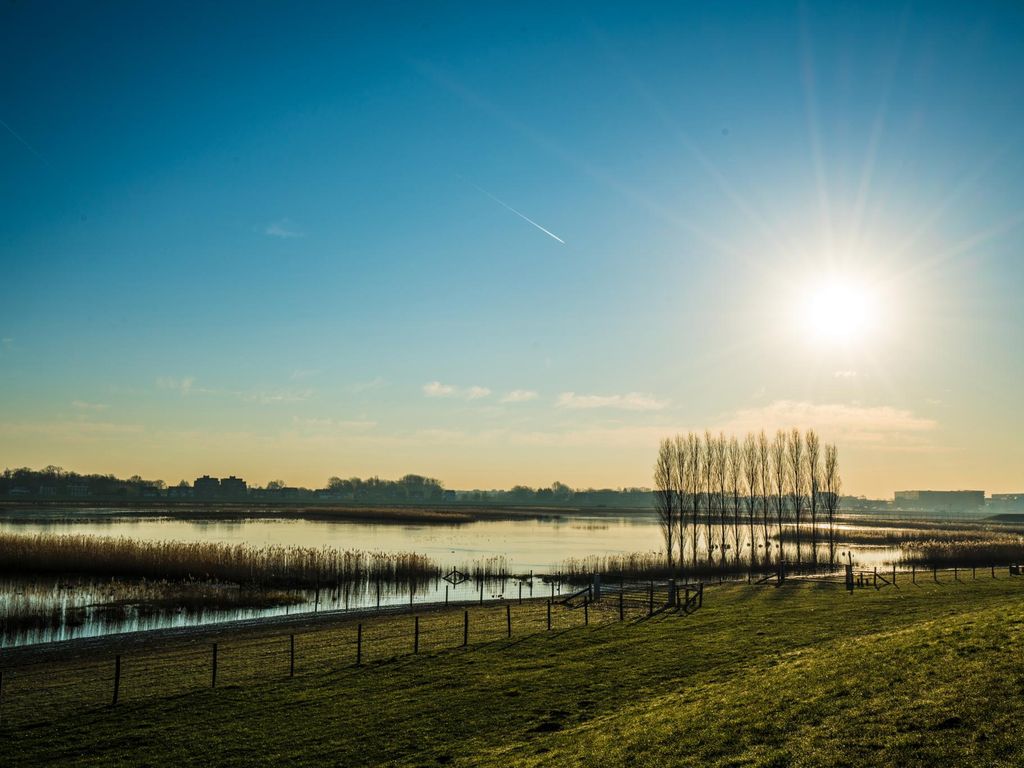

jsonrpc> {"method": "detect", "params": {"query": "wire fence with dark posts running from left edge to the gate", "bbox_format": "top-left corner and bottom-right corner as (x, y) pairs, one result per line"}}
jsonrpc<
(0, 583), (703, 727)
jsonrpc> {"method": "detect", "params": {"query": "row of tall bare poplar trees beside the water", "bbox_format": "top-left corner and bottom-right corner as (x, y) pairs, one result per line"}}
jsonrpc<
(654, 429), (842, 570)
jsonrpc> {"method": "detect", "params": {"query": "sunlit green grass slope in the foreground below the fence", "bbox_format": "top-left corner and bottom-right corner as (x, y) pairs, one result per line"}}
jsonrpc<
(0, 571), (1024, 766)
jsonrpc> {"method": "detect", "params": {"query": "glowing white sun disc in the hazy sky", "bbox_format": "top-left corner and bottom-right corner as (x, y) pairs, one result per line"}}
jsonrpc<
(798, 275), (879, 346)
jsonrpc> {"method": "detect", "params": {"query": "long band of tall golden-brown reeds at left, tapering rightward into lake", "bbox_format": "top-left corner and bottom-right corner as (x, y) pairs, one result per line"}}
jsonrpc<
(0, 534), (439, 589)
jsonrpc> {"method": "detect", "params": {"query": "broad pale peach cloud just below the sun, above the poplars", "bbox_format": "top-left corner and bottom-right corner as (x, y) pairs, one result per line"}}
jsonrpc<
(720, 400), (938, 446)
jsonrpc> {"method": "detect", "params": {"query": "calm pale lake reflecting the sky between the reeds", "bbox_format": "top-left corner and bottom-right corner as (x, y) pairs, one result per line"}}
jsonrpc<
(0, 510), (895, 645)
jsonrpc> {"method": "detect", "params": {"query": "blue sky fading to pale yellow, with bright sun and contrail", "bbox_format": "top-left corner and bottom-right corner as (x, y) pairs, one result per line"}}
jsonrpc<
(0, 2), (1024, 498)
